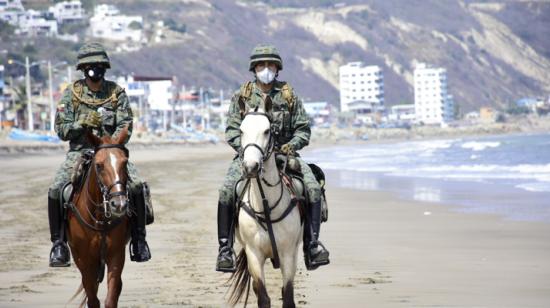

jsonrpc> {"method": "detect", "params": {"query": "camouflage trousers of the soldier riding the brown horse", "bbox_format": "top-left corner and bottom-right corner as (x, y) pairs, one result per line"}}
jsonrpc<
(48, 151), (143, 199)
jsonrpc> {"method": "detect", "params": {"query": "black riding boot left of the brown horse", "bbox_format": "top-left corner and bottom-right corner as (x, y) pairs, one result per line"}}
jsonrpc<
(48, 196), (71, 267)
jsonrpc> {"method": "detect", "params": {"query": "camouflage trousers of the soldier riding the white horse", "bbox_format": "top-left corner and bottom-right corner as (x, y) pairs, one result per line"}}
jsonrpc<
(220, 157), (321, 204)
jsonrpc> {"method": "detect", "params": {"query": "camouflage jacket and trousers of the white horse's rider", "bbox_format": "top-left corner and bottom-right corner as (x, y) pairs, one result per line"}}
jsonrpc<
(220, 81), (321, 204)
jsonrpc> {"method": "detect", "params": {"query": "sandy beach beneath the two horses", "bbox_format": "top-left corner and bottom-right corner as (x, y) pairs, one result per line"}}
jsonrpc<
(0, 145), (550, 307)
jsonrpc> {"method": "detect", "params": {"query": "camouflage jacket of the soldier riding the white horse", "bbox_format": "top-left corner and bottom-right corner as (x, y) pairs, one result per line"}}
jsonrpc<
(225, 81), (311, 151)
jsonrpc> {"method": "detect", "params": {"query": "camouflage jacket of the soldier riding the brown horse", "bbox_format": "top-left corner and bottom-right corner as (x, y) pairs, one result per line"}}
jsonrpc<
(55, 79), (133, 151)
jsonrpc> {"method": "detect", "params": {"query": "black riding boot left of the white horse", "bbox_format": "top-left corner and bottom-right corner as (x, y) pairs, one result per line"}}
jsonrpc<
(216, 202), (235, 273)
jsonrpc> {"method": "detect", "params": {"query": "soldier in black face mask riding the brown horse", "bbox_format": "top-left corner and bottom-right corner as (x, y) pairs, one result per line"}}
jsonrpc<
(48, 43), (151, 267)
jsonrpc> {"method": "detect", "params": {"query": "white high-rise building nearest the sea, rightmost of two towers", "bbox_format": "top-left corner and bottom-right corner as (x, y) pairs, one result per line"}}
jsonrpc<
(414, 63), (454, 125)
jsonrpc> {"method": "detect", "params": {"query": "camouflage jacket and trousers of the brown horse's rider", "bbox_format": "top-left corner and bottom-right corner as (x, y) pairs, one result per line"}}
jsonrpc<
(49, 80), (142, 200)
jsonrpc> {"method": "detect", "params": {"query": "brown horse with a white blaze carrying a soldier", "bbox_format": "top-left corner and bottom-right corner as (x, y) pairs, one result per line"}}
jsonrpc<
(67, 128), (130, 307)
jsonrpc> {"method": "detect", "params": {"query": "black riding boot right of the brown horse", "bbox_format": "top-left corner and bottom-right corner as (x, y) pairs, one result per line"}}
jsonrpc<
(130, 190), (151, 262)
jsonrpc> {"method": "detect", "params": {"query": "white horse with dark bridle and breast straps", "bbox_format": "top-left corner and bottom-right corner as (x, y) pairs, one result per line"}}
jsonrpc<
(230, 97), (303, 308)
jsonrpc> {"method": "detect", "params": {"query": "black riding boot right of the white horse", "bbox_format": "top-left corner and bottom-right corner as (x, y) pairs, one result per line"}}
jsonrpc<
(304, 202), (330, 270)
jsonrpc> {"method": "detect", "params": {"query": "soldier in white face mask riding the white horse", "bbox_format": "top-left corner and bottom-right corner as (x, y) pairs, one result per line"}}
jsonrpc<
(216, 45), (329, 272)
